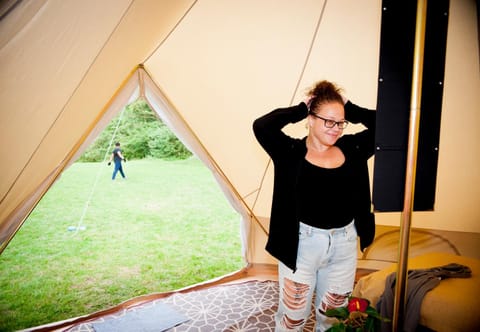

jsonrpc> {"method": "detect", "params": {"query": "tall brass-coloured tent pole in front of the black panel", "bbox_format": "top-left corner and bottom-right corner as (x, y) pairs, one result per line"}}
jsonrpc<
(392, 0), (427, 332)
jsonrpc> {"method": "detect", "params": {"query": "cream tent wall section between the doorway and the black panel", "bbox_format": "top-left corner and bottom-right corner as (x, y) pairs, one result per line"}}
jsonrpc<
(145, 0), (381, 263)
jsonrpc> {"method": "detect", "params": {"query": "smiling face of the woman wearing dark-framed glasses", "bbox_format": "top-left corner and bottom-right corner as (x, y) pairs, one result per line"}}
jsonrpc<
(308, 102), (345, 146)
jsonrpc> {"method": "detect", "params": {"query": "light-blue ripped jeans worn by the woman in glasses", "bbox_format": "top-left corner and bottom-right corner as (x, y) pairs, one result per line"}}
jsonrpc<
(275, 221), (357, 332)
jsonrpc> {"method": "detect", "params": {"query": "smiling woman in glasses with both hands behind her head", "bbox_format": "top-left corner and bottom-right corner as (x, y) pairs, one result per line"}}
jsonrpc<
(253, 81), (375, 331)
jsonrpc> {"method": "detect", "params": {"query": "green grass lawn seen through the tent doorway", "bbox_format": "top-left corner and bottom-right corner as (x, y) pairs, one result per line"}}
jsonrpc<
(0, 158), (244, 331)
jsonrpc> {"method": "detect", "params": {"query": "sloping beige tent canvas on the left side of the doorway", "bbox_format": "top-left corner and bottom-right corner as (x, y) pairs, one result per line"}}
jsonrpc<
(0, 0), (197, 250)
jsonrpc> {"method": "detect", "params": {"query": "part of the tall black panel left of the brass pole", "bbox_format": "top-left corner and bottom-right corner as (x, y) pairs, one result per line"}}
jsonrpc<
(373, 0), (416, 211)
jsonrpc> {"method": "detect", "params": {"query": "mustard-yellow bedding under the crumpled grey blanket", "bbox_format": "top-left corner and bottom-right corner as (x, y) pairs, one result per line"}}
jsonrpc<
(353, 253), (480, 332)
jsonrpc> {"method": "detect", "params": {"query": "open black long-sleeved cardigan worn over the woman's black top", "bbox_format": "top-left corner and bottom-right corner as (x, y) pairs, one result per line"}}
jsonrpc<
(253, 101), (376, 271)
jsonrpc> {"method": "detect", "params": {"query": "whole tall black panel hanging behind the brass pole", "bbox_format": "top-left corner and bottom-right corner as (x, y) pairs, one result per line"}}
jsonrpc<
(373, 0), (449, 212)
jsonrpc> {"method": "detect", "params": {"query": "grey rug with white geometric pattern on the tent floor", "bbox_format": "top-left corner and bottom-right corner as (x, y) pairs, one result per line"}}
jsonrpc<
(68, 281), (315, 332)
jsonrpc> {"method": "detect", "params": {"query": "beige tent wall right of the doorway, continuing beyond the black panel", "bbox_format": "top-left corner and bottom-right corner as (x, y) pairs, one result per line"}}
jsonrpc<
(146, 0), (480, 266)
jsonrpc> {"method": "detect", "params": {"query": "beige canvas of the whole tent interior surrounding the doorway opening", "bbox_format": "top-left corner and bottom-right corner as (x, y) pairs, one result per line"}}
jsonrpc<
(0, 0), (480, 330)
